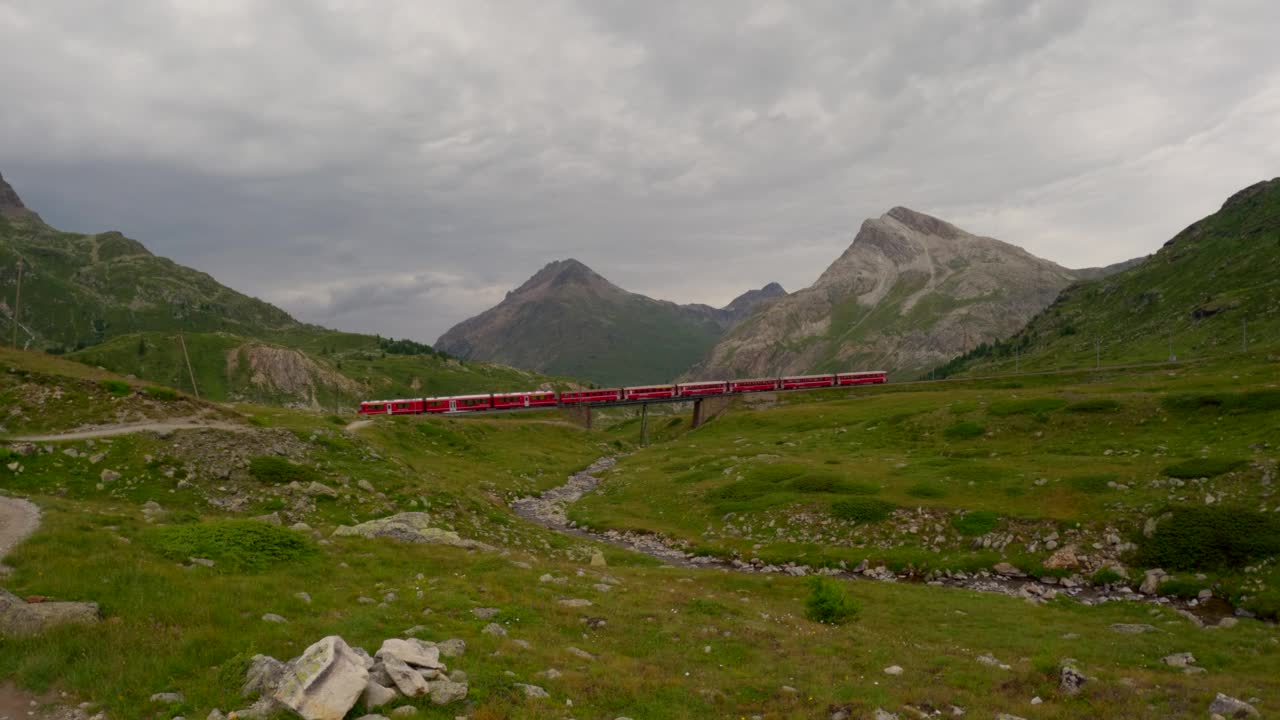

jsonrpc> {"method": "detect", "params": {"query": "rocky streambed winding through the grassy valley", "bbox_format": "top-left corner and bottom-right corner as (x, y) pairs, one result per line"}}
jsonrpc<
(512, 457), (1247, 632)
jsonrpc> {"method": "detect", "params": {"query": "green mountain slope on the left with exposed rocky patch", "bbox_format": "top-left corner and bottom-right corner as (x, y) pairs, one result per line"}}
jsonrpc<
(0, 167), (552, 407)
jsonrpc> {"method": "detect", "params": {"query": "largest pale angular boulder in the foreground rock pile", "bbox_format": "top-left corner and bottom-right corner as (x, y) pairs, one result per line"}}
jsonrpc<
(275, 635), (369, 720)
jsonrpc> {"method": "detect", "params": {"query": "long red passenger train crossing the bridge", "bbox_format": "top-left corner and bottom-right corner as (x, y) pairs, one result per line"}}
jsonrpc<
(360, 370), (888, 415)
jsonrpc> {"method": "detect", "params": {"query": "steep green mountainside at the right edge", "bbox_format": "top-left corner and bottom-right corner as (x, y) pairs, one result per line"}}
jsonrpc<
(941, 178), (1280, 374)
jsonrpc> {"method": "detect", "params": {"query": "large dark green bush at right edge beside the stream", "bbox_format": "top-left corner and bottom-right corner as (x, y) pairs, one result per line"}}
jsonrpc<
(1137, 506), (1280, 570)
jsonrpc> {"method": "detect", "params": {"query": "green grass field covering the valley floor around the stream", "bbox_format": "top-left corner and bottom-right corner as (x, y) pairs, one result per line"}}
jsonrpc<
(0, 348), (1280, 720)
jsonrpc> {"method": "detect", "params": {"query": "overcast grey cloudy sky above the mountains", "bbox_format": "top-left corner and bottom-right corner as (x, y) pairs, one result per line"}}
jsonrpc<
(0, 0), (1280, 342)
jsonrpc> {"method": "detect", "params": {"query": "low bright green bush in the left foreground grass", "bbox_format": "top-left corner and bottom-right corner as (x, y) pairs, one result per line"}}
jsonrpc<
(145, 520), (315, 573)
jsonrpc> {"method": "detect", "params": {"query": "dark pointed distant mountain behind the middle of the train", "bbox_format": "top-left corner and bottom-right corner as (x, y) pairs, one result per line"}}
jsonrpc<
(435, 260), (786, 384)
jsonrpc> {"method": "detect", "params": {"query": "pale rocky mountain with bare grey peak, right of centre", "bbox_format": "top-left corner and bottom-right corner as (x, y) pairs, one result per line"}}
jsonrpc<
(687, 208), (1103, 378)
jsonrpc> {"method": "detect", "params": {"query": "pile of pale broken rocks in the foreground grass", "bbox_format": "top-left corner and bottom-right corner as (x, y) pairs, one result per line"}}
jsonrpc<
(230, 635), (467, 720)
